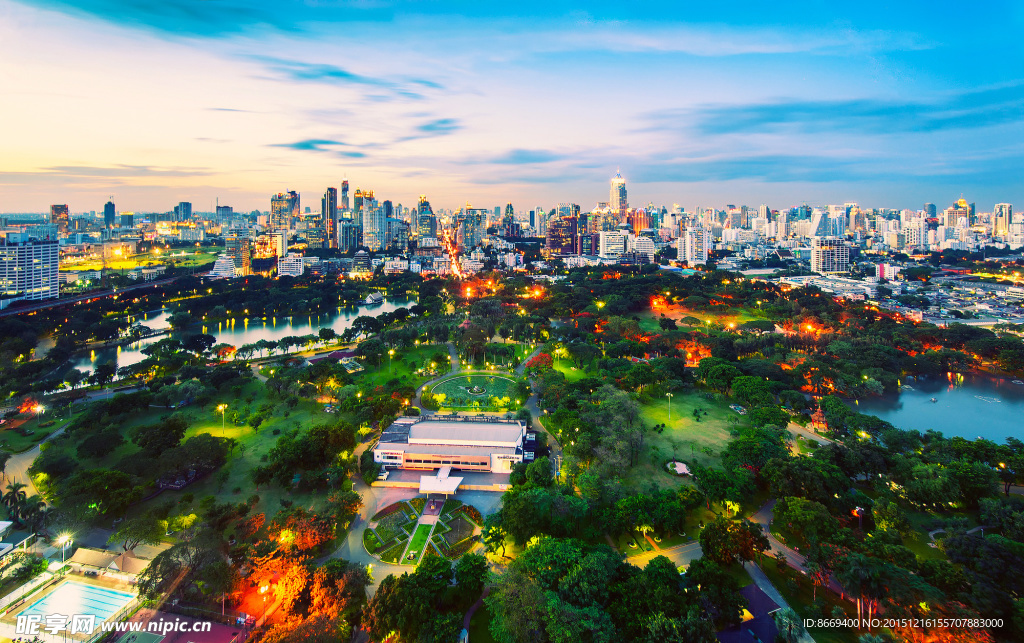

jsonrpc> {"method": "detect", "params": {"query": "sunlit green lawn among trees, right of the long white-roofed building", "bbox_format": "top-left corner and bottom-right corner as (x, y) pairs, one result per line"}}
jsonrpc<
(628, 391), (741, 488)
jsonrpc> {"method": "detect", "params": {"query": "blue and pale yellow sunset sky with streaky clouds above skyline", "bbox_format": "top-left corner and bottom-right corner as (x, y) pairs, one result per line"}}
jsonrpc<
(0, 0), (1024, 213)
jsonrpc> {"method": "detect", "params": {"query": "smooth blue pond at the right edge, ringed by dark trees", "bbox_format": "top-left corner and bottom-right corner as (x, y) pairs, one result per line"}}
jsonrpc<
(854, 373), (1024, 443)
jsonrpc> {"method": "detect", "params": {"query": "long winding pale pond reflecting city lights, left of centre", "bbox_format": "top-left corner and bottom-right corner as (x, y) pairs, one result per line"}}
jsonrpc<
(71, 299), (416, 373)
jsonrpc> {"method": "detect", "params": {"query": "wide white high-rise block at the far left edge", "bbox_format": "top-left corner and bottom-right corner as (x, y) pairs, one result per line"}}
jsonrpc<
(0, 230), (60, 303)
